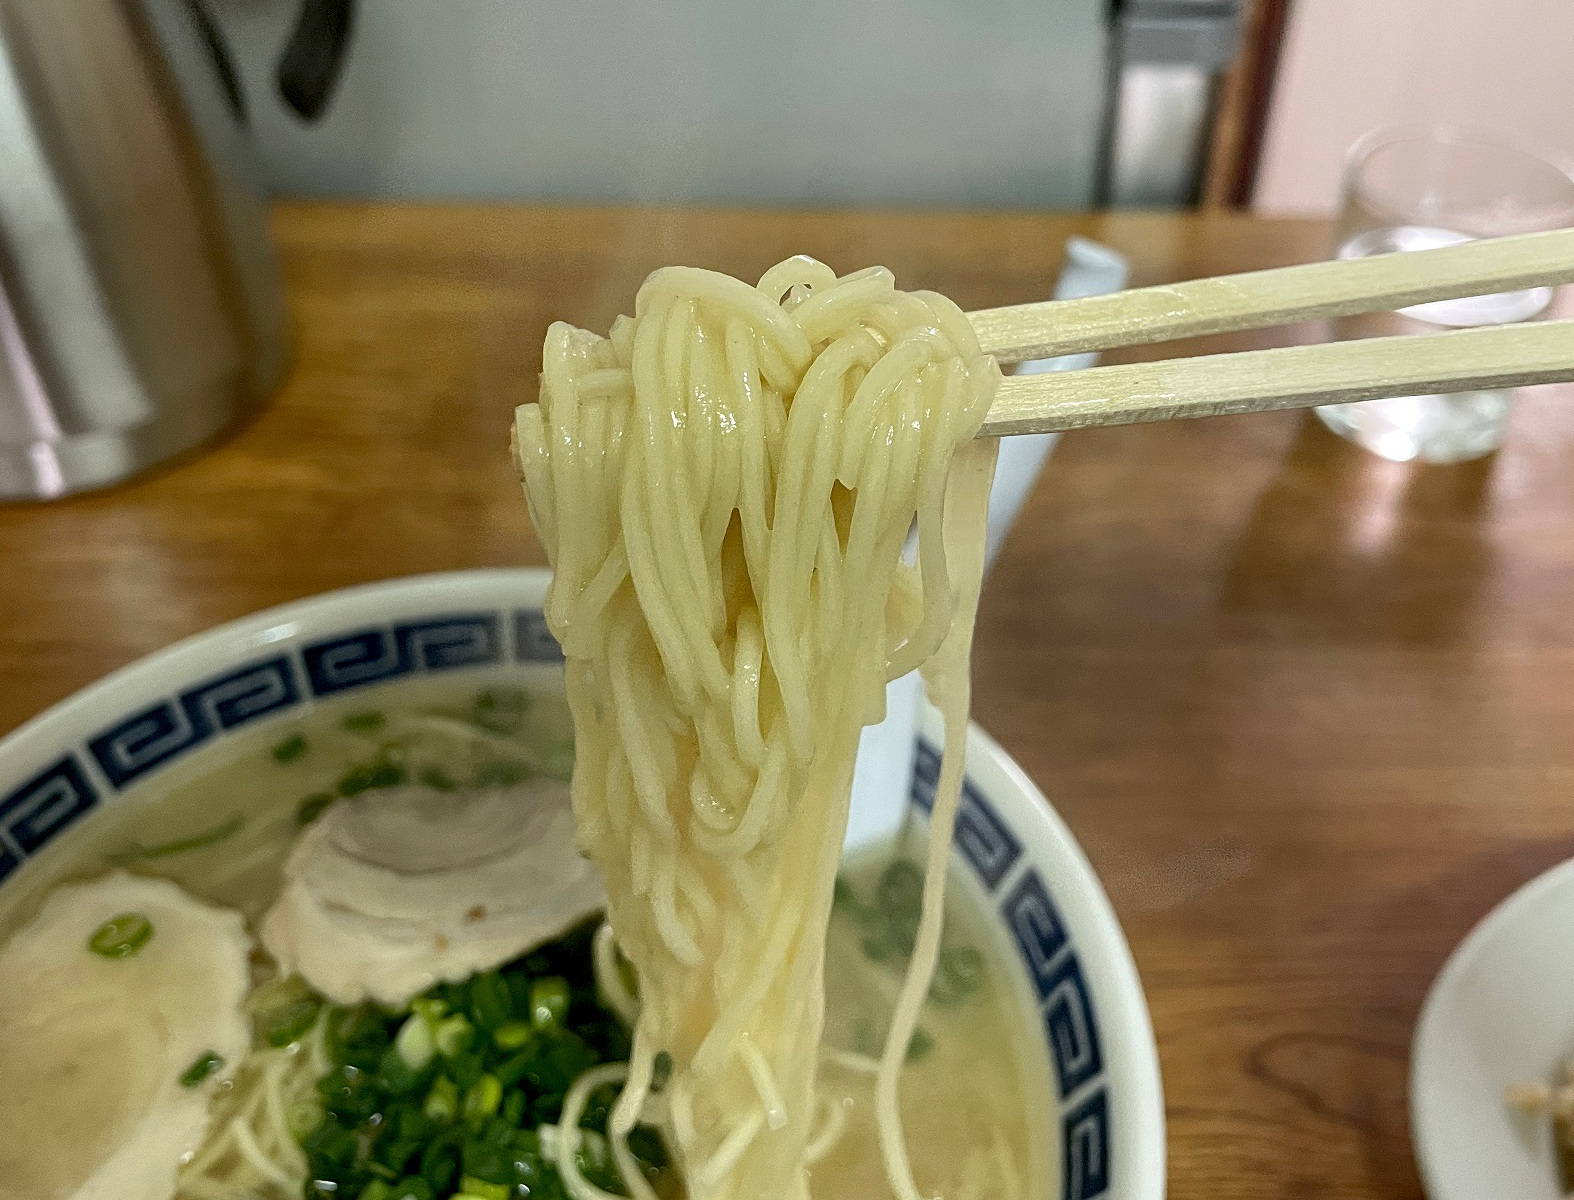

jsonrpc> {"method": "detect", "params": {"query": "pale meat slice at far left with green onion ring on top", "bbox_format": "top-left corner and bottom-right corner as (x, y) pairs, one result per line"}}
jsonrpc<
(0, 871), (250, 1200)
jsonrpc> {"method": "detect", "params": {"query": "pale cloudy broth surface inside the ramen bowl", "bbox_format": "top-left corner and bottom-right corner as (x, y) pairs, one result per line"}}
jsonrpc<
(0, 668), (1058, 1200)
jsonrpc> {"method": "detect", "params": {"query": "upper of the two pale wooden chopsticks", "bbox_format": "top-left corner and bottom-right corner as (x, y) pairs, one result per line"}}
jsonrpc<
(968, 228), (1574, 362)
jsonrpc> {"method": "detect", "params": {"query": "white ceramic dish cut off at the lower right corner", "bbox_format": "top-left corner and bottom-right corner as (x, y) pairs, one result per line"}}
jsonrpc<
(1410, 861), (1574, 1200)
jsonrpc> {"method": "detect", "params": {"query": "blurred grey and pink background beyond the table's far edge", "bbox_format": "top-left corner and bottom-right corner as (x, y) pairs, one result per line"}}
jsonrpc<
(206, 0), (1574, 213)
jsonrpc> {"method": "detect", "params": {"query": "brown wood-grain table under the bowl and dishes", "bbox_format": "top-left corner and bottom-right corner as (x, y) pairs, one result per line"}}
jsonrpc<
(0, 203), (1574, 1200)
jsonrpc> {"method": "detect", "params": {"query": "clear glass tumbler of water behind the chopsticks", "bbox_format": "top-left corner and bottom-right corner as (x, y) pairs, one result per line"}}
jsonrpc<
(1317, 126), (1574, 463)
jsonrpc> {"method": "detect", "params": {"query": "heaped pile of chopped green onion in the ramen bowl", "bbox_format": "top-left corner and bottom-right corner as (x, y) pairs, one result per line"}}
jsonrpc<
(294, 923), (626, 1200)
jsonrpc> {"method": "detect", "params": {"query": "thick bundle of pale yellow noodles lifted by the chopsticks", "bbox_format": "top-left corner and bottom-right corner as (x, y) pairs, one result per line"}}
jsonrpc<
(515, 257), (998, 1200)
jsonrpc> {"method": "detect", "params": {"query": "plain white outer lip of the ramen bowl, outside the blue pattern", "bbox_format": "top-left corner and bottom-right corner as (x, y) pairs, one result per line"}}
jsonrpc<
(0, 567), (1166, 1200)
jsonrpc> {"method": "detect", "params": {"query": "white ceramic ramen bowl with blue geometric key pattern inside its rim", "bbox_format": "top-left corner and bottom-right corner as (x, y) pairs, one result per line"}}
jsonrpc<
(0, 570), (1165, 1200)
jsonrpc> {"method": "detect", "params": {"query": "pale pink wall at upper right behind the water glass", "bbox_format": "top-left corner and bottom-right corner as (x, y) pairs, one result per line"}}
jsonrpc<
(1254, 0), (1574, 213)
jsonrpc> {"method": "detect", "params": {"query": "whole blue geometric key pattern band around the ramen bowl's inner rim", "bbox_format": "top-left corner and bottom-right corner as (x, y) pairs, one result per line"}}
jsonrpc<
(0, 609), (1110, 1200)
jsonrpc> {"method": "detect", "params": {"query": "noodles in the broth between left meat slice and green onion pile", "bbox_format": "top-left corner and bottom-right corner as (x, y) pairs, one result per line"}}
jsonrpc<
(175, 1016), (334, 1200)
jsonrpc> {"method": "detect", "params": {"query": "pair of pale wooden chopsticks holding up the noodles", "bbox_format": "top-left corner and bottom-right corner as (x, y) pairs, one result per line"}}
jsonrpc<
(968, 228), (1574, 436)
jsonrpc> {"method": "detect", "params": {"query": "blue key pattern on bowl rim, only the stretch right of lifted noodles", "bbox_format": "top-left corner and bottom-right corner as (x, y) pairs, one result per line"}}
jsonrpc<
(911, 739), (1111, 1200)
